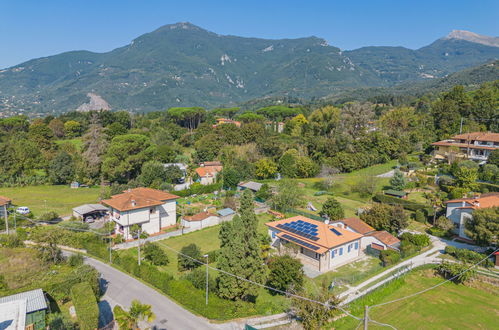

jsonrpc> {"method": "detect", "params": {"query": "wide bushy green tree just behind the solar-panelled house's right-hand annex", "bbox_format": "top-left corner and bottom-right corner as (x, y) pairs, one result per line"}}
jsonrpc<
(360, 203), (408, 234)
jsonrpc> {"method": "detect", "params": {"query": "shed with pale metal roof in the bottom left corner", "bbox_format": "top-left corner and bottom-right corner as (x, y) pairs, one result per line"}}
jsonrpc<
(0, 289), (48, 330)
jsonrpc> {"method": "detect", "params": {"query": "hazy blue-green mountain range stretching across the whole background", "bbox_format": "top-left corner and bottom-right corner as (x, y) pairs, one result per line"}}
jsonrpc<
(0, 23), (499, 115)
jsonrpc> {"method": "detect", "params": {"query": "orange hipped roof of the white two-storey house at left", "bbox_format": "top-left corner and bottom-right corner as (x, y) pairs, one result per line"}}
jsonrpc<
(102, 188), (179, 211)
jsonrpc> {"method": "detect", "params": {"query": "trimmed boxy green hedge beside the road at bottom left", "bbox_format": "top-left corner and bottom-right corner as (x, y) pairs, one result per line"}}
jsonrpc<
(71, 282), (99, 330)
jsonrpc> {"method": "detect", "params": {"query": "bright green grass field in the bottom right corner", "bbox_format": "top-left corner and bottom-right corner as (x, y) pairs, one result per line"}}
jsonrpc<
(335, 270), (499, 329)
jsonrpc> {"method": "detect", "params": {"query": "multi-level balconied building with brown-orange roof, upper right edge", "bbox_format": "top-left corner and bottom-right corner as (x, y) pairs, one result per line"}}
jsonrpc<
(432, 132), (499, 163)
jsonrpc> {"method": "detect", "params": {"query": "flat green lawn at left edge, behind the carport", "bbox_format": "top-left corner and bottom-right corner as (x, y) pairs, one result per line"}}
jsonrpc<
(0, 185), (100, 216)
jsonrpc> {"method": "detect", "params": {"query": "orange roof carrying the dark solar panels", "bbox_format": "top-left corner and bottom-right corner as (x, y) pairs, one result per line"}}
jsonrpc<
(265, 215), (362, 253)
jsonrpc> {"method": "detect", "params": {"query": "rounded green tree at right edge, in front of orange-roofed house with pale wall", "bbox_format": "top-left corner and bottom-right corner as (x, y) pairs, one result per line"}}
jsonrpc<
(465, 206), (499, 246)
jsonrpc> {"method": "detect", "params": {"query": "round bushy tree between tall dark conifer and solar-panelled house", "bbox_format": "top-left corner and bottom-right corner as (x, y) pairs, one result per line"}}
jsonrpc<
(267, 255), (304, 294)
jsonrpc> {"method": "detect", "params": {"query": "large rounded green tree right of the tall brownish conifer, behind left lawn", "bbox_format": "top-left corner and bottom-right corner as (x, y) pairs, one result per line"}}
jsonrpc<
(102, 134), (156, 183)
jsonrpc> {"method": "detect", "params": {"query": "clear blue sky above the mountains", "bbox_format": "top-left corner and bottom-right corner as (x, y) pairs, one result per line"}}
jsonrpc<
(0, 0), (499, 68)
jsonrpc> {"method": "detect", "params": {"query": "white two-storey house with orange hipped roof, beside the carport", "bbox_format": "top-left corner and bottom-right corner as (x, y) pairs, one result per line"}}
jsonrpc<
(101, 188), (179, 239)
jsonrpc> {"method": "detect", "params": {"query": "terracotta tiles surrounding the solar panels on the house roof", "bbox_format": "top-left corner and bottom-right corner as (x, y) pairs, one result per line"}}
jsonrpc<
(265, 215), (362, 253)
